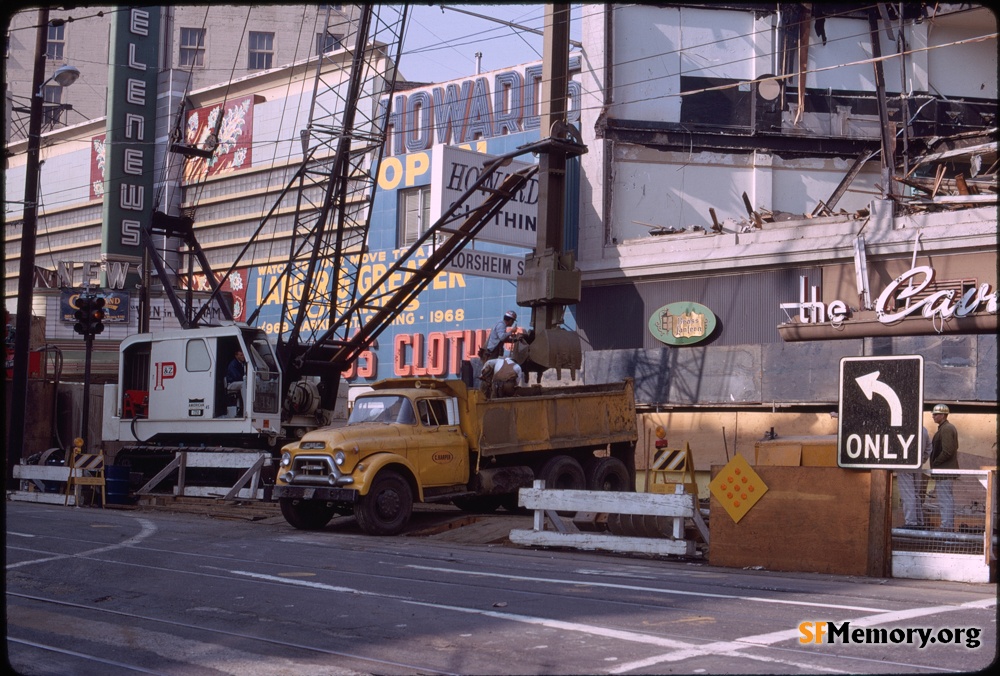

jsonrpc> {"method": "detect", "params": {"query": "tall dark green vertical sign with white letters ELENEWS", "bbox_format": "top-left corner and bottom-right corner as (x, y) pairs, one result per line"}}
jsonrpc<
(101, 6), (160, 289)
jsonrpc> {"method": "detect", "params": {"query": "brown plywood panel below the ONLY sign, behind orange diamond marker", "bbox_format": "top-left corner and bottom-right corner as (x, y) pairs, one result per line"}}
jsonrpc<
(709, 466), (872, 575)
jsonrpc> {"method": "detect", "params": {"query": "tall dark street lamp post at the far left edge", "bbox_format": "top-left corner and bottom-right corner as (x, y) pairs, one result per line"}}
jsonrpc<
(7, 8), (80, 488)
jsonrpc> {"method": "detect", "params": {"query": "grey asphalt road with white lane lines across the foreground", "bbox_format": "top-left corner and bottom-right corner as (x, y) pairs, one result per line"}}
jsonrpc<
(5, 502), (997, 676)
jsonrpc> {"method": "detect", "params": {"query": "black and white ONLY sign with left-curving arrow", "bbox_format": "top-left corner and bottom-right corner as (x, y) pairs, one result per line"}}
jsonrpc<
(837, 355), (924, 469)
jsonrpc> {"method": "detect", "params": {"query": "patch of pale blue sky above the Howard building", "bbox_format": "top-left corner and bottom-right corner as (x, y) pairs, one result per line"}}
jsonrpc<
(400, 4), (581, 82)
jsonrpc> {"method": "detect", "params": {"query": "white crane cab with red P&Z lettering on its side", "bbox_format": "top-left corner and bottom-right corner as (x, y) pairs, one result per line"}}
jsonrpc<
(103, 324), (281, 446)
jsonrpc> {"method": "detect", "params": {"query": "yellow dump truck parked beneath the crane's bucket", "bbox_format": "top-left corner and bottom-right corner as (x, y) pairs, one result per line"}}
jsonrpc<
(274, 378), (638, 535)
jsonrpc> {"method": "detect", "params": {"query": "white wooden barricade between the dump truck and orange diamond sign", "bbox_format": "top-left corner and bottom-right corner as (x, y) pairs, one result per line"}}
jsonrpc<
(510, 481), (709, 556)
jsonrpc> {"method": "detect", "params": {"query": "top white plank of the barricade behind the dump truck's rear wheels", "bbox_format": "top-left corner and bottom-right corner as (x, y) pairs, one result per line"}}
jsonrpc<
(518, 488), (697, 517)
